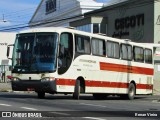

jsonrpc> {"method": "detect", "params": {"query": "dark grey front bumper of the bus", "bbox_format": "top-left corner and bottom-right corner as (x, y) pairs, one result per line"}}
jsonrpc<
(11, 80), (56, 93)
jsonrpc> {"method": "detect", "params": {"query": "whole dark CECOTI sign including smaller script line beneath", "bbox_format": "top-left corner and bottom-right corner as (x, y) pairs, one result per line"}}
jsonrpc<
(112, 14), (144, 38)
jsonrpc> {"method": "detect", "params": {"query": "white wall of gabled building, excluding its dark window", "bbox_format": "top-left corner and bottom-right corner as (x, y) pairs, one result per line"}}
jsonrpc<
(29, 0), (103, 27)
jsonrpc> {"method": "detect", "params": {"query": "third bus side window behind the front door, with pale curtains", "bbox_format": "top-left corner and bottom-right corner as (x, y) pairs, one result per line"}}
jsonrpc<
(106, 41), (120, 59)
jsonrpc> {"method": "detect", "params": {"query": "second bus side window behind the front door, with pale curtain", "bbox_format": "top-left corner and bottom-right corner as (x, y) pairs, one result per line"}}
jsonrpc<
(92, 38), (106, 56)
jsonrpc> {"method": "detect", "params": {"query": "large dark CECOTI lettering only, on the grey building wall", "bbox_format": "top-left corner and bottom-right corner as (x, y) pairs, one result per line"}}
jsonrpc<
(115, 14), (144, 30)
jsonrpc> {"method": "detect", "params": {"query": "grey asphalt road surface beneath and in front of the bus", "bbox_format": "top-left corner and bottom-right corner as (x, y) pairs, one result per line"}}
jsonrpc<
(0, 92), (160, 120)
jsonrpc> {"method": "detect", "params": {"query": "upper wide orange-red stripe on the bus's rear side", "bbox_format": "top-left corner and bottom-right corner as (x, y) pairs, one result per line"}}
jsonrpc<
(100, 62), (154, 75)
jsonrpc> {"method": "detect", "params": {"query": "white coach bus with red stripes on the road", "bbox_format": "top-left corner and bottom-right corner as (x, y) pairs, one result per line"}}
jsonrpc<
(7, 27), (154, 99)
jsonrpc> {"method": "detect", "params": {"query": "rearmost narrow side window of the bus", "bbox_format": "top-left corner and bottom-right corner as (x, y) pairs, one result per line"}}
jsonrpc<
(144, 49), (152, 64)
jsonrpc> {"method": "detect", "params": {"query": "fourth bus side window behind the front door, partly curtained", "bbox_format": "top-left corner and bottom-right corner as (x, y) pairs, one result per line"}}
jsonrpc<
(121, 44), (132, 60)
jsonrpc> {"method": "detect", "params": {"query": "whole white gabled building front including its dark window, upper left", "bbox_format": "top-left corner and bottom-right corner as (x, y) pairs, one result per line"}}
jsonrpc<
(29, 0), (103, 27)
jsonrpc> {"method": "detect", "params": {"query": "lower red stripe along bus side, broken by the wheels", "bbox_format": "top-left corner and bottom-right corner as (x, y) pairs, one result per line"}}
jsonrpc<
(56, 79), (153, 89)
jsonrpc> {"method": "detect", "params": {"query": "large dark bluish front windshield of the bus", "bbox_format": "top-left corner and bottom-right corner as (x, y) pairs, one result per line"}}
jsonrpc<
(13, 33), (58, 73)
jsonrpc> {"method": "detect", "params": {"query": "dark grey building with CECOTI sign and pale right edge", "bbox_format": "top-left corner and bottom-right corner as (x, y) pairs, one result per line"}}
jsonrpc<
(70, 0), (160, 94)
